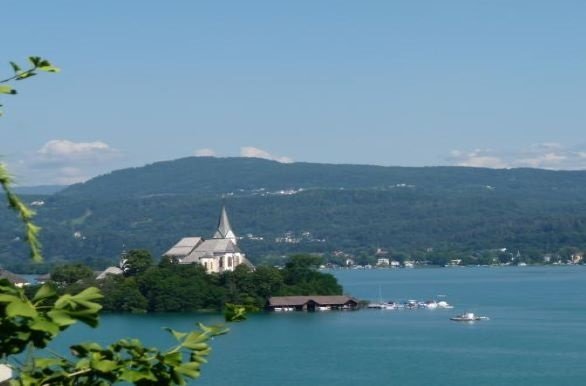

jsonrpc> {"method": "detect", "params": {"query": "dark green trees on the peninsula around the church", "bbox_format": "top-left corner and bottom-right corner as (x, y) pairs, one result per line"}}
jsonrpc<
(46, 250), (342, 312)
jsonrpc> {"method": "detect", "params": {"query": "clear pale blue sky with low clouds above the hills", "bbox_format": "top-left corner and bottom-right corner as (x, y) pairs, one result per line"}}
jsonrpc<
(0, 0), (586, 185)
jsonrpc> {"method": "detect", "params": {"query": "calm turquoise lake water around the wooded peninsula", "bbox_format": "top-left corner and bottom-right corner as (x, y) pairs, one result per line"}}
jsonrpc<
(53, 266), (586, 386)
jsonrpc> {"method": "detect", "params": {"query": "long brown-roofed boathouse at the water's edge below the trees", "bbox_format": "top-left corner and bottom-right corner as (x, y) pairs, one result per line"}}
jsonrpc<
(267, 295), (358, 311)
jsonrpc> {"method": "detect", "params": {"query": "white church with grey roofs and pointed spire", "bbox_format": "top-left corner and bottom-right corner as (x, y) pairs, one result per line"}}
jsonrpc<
(163, 206), (254, 273)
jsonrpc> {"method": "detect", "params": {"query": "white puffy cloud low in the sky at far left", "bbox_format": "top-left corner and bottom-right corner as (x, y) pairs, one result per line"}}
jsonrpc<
(37, 139), (117, 162)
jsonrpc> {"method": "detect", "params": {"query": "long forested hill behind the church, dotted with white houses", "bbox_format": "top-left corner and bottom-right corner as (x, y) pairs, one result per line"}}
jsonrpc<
(0, 157), (586, 267)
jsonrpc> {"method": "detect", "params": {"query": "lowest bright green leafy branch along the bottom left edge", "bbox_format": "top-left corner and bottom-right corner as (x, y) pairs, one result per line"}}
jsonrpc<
(14, 324), (228, 386)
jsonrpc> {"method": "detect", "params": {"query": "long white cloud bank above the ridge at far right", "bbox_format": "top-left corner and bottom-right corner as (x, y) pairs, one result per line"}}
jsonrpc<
(447, 142), (586, 170)
